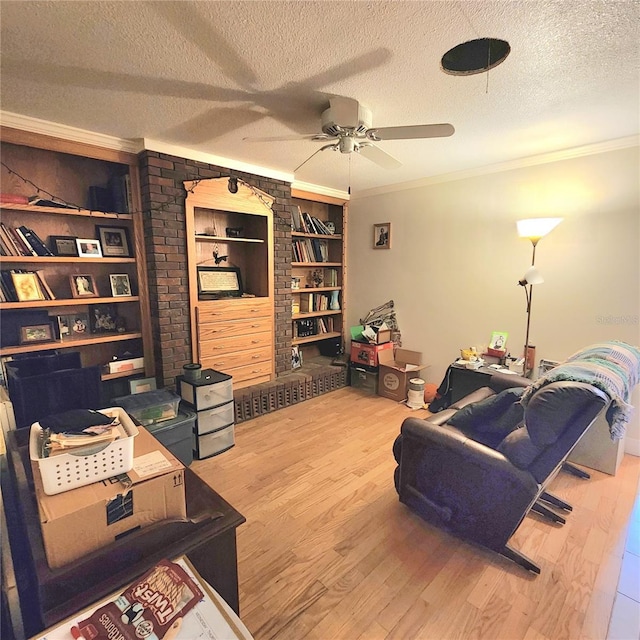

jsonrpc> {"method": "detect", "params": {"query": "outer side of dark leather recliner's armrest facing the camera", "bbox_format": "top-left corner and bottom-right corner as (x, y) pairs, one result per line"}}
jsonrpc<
(398, 418), (541, 551)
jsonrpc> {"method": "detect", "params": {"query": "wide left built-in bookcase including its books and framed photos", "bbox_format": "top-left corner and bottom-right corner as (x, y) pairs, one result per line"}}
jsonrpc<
(0, 127), (155, 380)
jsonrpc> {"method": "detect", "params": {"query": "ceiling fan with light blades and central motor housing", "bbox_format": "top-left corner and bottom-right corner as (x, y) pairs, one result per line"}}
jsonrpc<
(245, 96), (455, 173)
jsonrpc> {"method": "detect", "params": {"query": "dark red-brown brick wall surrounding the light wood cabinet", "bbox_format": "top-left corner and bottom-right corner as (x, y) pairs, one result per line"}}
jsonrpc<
(138, 151), (292, 386)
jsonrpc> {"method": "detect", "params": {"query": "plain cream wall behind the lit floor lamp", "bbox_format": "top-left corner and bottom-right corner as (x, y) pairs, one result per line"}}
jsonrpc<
(347, 146), (640, 455)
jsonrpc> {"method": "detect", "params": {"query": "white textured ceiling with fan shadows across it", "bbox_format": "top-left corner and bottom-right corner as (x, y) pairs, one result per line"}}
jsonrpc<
(0, 0), (640, 193)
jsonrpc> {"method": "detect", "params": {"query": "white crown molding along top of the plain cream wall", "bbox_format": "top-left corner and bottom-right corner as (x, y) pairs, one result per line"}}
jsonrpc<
(351, 135), (640, 200)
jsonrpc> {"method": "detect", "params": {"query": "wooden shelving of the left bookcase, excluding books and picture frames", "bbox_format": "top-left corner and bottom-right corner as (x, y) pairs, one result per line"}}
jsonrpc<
(0, 127), (155, 379)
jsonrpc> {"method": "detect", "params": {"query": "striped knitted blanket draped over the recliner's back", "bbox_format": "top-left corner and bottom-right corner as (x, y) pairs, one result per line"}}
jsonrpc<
(520, 340), (640, 440)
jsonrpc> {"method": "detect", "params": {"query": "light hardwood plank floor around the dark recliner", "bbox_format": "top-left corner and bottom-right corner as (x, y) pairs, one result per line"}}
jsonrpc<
(192, 387), (640, 640)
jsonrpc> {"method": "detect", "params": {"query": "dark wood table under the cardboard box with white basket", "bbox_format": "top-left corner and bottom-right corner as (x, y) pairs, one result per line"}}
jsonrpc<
(2, 429), (245, 636)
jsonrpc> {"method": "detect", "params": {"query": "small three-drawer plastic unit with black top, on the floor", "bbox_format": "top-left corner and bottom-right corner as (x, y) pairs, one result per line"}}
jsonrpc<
(176, 369), (235, 460)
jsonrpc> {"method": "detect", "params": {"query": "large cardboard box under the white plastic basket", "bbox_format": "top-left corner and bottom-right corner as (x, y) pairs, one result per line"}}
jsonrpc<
(32, 427), (187, 569)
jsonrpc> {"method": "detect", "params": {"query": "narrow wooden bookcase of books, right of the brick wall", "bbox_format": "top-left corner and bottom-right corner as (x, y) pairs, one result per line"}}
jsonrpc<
(291, 189), (347, 355)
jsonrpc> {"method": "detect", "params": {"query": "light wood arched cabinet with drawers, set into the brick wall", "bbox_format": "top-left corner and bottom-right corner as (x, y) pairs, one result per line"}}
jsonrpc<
(185, 178), (275, 388)
